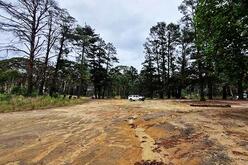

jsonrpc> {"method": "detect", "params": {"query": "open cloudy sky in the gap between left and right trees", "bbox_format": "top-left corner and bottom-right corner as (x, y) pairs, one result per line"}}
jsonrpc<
(58, 0), (182, 70)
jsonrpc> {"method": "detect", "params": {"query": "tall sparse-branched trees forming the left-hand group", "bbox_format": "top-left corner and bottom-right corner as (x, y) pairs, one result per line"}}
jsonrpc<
(0, 0), (118, 98)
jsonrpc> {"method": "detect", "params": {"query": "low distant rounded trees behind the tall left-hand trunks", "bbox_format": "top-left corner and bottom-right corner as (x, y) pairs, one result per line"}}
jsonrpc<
(0, 57), (142, 98)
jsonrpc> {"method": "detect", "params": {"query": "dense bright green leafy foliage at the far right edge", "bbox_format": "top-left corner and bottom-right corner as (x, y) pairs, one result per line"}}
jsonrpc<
(194, 0), (248, 99)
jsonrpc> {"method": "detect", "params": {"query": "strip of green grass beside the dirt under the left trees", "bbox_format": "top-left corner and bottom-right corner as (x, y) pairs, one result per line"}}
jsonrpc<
(0, 94), (89, 113)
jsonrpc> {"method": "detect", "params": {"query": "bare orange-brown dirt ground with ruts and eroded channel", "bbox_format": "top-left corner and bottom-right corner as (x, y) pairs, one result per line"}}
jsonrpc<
(0, 100), (248, 165)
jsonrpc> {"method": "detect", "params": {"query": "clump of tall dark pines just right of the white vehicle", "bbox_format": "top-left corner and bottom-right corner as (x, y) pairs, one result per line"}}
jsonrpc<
(141, 22), (180, 98)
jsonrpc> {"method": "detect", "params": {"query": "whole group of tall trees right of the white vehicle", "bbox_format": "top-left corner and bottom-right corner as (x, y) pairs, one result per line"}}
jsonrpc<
(141, 0), (248, 100)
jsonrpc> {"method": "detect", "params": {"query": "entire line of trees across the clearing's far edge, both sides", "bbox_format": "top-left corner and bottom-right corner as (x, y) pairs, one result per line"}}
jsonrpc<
(0, 0), (248, 100)
